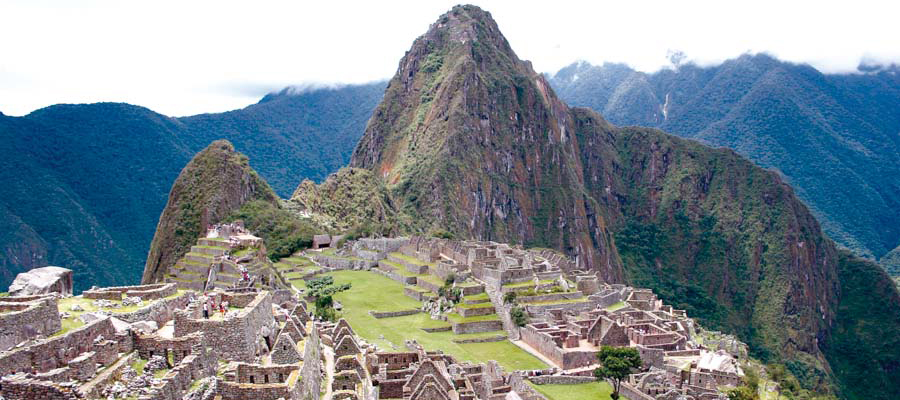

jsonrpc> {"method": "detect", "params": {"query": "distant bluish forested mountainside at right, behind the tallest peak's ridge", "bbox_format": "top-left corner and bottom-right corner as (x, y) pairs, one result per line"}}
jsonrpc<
(549, 60), (900, 266)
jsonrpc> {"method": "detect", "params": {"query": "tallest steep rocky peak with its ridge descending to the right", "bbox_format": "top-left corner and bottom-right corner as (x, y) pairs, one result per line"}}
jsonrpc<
(351, 6), (852, 394)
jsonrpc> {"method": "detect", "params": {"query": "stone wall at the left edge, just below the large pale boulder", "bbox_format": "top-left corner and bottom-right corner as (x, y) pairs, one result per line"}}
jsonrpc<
(0, 296), (62, 351)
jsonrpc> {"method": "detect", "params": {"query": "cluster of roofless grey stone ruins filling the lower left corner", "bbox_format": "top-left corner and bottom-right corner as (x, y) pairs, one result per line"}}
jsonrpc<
(0, 270), (322, 400)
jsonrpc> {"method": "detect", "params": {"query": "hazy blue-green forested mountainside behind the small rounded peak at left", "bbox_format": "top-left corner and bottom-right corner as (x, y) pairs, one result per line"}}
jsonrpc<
(0, 83), (384, 291)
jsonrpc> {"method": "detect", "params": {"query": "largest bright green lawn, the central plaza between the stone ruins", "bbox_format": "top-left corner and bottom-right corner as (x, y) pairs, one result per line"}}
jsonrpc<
(293, 271), (547, 371)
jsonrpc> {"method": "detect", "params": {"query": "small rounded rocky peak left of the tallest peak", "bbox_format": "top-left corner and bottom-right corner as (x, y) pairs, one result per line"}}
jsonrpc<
(142, 140), (278, 283)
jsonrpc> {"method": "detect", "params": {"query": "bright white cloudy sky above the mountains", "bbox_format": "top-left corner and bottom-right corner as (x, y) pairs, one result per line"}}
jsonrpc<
(0, 0), (900, 116)
